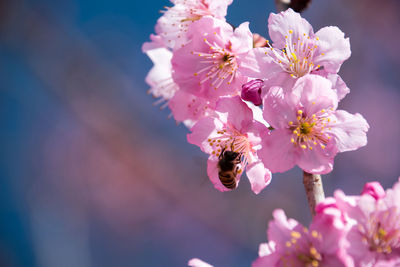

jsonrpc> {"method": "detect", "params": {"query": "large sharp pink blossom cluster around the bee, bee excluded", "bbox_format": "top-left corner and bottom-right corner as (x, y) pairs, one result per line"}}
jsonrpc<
(143, 0), (369, 194)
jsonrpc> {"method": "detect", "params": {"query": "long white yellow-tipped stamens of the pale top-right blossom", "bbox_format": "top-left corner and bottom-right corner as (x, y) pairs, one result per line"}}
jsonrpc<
(266, 30), (324, 78)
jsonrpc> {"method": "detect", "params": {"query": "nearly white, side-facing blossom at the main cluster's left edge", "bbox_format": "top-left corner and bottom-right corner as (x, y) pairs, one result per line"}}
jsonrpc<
(142, 36), (179, 109)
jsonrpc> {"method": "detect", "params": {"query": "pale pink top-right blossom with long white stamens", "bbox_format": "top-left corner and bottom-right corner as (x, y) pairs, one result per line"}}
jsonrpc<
(251, 9), (351, 100)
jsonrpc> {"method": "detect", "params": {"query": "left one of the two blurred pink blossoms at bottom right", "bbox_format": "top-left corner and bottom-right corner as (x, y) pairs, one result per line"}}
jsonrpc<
(252, 209), (353, 267)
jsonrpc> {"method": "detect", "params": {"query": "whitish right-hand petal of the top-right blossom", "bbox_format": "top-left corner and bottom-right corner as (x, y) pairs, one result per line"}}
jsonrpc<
(314, 26), (351, 73)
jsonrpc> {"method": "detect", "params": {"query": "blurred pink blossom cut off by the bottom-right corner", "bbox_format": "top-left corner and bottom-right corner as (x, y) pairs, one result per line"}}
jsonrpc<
(335, 181), (400, 267)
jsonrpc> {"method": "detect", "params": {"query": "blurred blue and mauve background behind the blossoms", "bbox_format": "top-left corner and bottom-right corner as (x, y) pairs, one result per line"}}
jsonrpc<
(0, 0), (400, 267)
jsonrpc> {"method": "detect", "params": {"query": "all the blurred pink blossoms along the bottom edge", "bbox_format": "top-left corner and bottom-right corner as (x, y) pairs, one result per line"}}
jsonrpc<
(189, 179), (400, 267)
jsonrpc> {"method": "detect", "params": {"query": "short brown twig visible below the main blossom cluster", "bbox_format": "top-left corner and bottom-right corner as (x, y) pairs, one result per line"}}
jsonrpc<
(303, 172), (325, 217)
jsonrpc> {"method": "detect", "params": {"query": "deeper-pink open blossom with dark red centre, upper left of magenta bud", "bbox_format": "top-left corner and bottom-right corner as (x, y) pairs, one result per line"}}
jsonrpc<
(172, 17), (252, 100)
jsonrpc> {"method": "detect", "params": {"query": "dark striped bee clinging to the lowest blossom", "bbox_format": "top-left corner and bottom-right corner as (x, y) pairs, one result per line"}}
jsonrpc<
(218, 144), (242, 190)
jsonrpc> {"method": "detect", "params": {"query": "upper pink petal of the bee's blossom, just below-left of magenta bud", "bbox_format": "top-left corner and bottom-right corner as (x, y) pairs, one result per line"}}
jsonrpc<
(215, 96), (253, 132)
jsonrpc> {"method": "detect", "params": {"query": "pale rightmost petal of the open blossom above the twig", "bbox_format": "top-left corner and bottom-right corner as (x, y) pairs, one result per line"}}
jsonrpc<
(329, 110), (369, 152)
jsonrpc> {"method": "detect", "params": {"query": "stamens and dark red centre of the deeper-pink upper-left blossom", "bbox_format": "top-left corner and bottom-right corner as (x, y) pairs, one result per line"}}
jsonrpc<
(191, 38), (238, 90)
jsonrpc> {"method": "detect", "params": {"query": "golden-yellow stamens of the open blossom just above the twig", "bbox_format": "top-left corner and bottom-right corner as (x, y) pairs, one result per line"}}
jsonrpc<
(288, 109), (332, 150)
